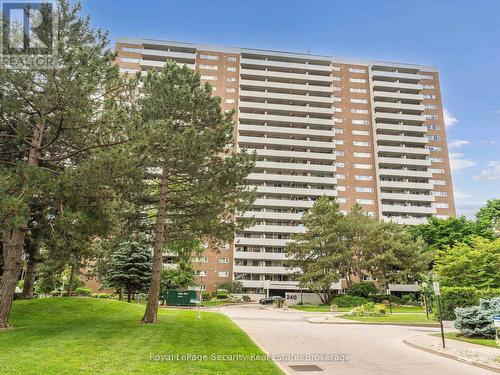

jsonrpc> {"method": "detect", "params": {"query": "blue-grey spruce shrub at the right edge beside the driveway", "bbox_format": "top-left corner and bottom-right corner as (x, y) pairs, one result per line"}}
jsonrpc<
(455, 297), (500, 338)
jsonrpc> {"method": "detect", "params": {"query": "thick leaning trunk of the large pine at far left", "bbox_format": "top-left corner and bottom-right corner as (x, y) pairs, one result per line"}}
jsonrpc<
(0, 117), (45, 329)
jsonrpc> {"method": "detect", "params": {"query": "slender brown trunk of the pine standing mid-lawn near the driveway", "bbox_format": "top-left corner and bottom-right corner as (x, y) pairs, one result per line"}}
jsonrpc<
(142, 169), (168, 323)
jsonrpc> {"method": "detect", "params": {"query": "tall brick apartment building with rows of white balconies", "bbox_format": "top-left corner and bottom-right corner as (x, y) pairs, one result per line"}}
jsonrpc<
(116, 38), (455, 294)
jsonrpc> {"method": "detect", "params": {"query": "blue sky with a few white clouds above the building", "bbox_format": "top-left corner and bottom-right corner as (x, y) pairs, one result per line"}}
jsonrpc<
(81, 0), (500, 217)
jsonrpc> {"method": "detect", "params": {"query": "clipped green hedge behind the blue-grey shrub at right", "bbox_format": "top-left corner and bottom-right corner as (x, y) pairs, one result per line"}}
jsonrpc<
(434, 286), (500, 320)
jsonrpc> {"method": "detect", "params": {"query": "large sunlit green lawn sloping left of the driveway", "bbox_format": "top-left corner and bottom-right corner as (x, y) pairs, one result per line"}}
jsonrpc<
(0, 298), (281, 375)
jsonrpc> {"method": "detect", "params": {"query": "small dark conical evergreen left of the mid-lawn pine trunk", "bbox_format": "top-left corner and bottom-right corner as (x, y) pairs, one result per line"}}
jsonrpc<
(106, 241), (151, 302)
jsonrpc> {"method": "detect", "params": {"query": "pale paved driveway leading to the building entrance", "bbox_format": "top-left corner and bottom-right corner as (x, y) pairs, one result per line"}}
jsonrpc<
(220, 305), (492, 375)
